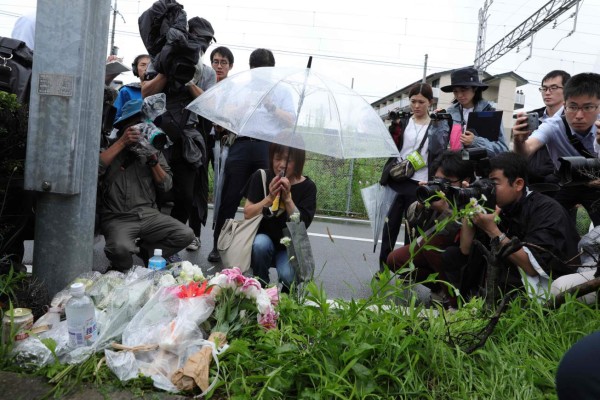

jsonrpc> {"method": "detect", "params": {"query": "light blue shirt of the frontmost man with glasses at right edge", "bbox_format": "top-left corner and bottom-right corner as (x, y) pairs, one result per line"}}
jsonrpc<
(531, 113), (596, 169)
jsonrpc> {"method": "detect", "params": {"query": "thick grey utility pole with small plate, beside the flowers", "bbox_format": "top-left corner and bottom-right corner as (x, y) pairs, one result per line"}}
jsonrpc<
(25, 0), (110, 296)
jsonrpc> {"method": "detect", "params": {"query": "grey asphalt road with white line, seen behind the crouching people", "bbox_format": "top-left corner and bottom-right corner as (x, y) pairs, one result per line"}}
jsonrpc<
(24, 209), (428, 300)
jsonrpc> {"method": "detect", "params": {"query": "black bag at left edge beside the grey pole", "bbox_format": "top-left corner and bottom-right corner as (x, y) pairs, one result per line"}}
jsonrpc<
(0, 37), (33, 104)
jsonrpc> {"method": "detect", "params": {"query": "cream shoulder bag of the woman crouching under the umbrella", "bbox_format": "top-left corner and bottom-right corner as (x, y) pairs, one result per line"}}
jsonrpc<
(217, 169), (267, 273)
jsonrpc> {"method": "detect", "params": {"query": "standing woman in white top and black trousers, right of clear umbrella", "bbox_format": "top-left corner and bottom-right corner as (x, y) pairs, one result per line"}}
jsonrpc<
(379, 83), (449, 269)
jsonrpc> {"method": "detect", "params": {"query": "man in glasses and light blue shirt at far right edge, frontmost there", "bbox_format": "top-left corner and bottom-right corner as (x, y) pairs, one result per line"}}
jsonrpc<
(513, 73), (600, 225)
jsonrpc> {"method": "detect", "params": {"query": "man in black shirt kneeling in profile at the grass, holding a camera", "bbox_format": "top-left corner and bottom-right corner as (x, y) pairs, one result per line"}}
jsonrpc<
(443, 153), (579, 297)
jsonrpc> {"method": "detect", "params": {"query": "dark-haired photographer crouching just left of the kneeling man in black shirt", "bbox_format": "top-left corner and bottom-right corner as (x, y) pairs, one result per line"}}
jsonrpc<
(387, 150), (474, 307)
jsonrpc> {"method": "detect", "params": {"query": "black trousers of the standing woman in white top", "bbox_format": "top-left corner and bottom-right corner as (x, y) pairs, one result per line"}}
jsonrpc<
(379, 180), (419, 269)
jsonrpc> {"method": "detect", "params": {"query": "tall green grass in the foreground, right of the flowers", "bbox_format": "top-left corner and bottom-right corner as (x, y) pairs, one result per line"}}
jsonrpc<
(207, 283), (600, 399)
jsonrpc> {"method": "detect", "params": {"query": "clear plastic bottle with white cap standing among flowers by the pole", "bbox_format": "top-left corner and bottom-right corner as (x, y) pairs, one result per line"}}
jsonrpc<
(65, 282), (98, 347)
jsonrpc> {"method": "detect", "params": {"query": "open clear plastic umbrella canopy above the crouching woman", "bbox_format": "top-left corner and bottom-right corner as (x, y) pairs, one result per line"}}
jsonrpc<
(187, 67), (399, 158)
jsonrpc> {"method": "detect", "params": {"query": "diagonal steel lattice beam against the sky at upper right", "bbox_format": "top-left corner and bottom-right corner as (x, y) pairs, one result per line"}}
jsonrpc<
(474, 0), (581, 71)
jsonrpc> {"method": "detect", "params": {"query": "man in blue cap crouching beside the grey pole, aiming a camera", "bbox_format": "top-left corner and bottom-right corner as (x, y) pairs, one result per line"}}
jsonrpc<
(98, 100), (194, 271)
